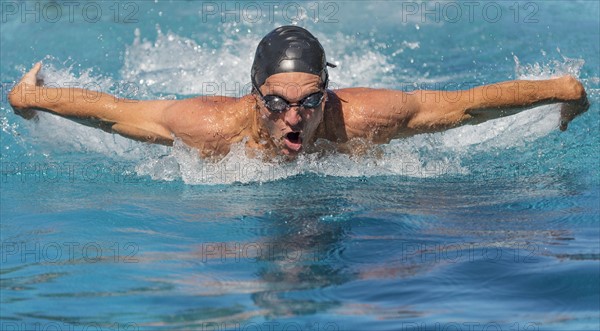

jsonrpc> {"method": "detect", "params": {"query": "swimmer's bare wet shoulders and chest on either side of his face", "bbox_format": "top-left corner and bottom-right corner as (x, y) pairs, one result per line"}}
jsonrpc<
(165, 88), (418, 158)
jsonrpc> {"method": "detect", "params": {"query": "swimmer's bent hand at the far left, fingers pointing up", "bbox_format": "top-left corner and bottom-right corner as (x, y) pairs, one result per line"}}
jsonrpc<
(8, 62), (42, 120)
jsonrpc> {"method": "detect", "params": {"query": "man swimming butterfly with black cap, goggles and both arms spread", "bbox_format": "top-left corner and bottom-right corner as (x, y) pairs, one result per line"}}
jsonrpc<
(9, 26), (589, 158)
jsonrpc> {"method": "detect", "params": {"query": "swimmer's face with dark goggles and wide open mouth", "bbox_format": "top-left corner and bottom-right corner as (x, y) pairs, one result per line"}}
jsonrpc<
(256, 72), (327, 155)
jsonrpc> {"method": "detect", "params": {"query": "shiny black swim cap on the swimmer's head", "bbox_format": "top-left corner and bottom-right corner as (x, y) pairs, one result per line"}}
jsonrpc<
(251, 25), (335, 89)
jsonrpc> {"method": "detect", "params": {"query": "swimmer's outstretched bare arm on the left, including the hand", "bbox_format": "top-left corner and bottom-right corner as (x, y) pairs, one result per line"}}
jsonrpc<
(8, 62), (176, 145)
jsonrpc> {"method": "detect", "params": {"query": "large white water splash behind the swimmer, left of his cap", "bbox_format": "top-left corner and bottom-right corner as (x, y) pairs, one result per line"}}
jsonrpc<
(121, 25), (259, 96)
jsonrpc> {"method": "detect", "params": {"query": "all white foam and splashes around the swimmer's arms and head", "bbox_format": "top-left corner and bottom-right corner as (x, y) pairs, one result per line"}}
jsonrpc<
(16, 26), (583, 184)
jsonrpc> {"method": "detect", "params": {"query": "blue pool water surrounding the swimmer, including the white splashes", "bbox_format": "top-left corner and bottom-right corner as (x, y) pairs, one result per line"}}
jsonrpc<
(0, 1), (600, 331)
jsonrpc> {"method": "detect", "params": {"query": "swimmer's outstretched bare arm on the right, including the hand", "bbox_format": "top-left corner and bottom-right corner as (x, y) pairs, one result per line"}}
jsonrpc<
(407, 76), (589, 132)
